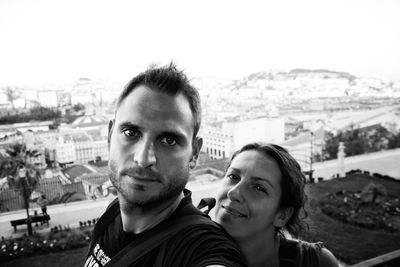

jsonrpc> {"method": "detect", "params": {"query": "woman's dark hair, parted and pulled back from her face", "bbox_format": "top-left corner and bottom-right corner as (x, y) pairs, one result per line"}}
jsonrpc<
(226, 143), (307, 237)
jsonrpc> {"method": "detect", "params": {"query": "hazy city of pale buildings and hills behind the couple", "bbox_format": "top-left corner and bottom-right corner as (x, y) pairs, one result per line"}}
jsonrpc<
(0, 69), (400, 266)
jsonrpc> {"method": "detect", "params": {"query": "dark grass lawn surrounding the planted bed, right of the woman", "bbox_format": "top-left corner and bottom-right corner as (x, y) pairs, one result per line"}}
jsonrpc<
(302, 174), (400, 264)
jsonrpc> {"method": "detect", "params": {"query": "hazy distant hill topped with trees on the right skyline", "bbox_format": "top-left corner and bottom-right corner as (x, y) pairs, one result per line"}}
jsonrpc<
(209, 68), (400, 98)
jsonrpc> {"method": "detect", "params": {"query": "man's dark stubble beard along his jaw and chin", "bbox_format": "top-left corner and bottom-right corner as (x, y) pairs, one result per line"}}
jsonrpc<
(109, 160), (189, 209)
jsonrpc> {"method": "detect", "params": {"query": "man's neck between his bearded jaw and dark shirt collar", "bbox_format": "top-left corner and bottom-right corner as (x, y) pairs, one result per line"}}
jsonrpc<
(118, 193), (183, 234)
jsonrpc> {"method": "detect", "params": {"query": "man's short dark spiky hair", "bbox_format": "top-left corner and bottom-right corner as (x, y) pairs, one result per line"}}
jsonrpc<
(116, 63), (201, 137)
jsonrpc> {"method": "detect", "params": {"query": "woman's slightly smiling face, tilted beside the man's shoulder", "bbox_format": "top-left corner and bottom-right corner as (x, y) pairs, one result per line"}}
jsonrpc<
(215, 150), (286, 239)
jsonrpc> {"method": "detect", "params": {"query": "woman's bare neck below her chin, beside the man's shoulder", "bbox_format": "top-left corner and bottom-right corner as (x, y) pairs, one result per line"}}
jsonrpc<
(236, 232), (280, 267)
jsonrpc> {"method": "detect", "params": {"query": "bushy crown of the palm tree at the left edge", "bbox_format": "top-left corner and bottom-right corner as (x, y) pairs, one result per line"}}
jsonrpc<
(0, 143), (40, 197)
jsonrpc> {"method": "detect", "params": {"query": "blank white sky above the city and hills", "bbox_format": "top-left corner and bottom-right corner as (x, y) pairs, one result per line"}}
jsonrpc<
(0, 0), (400, 86)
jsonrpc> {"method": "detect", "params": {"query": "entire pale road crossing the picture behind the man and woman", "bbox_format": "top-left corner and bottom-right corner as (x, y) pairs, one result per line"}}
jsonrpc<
(0, 149), (400, 237)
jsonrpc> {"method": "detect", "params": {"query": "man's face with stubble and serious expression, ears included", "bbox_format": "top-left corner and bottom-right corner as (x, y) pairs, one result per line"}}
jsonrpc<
(109, 86), (201, 206)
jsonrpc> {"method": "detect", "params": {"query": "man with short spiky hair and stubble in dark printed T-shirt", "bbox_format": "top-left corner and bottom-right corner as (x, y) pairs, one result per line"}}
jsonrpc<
(85, 64), (244, 267)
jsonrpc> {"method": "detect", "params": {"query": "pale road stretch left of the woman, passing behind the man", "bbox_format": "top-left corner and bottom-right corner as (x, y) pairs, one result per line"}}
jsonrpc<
(0, 182), (218, 237)
